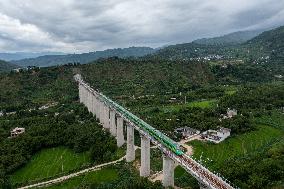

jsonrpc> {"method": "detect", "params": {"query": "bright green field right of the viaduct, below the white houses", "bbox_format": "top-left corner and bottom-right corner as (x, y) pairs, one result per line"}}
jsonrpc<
(188, 125), (283, 167)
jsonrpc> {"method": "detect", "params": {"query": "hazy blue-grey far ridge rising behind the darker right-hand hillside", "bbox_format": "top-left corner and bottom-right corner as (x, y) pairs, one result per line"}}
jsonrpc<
(193, 30), (263, 45)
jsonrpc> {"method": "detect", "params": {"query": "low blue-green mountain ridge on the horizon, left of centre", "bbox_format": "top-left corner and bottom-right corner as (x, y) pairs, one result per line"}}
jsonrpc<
(13, 47), (155, 67)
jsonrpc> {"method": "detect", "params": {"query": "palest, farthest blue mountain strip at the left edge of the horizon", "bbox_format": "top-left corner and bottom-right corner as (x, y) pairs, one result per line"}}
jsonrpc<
(0, 52), (64, 61)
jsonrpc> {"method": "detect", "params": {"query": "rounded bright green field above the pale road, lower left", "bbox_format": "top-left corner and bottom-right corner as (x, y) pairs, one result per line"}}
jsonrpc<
(11, 147), (91, 184)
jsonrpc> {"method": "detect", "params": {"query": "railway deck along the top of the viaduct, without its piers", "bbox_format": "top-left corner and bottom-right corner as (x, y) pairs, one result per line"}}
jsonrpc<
(74, 74), (233, 189)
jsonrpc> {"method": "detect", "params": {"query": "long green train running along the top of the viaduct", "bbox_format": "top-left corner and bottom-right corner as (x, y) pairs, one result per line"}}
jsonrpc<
(101, 94), (184, 156)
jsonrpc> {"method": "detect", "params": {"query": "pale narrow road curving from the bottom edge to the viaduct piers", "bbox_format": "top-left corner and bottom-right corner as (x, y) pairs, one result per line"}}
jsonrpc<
(19, 156), (126, 189)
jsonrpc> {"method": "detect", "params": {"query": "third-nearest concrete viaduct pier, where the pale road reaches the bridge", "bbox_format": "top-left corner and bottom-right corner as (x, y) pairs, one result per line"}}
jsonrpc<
(126, 123), (135, 162)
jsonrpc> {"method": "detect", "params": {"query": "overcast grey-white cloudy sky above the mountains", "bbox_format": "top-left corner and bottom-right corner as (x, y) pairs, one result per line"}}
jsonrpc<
(0, 0), (284, 53)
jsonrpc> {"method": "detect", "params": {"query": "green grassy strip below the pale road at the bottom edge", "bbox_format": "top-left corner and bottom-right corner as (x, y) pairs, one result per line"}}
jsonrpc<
(43, 168), (118, 189)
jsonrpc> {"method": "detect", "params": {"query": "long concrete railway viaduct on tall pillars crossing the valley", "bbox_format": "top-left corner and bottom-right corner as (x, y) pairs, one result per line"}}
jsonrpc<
(74, 74), (233, 189)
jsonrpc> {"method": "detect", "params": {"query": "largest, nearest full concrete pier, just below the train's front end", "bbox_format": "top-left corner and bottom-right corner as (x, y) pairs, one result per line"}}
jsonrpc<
(162, 155), (175, 187)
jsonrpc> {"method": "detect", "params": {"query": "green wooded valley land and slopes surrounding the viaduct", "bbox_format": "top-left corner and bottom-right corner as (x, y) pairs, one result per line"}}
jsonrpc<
(0, 27), (284, 189)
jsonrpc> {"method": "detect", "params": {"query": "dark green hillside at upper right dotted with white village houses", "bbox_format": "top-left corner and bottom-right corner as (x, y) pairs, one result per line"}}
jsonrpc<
(154, 26), (284, 63)
